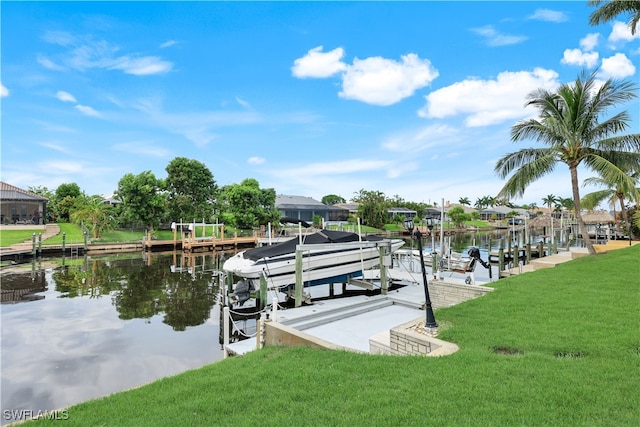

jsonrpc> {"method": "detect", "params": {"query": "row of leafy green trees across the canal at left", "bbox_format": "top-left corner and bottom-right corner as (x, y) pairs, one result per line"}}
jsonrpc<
(29, 157), (280, 238)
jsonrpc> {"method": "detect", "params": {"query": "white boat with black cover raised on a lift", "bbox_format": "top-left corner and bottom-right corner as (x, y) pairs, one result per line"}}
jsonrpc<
(222, 230), (404, 289)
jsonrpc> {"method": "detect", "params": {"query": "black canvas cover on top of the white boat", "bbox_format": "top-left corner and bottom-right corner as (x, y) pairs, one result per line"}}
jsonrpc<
(243, 230), (383, 261)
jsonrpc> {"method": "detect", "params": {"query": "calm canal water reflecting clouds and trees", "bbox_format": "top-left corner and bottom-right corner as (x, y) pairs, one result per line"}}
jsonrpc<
(0, 230), (568, 424)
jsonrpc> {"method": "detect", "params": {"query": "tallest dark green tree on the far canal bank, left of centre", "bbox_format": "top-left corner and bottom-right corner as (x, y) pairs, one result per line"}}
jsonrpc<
(165, 157), (218, 222)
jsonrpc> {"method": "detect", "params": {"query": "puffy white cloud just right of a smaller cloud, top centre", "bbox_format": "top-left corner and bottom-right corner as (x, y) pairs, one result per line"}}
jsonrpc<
(339, 53), (438, 106)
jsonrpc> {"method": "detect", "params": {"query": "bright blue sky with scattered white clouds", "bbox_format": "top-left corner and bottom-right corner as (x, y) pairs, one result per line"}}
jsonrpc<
(0, 1), (640, 206)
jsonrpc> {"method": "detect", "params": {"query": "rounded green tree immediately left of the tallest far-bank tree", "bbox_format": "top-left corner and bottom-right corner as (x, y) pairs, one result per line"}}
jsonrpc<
(116, 171), (167, 230)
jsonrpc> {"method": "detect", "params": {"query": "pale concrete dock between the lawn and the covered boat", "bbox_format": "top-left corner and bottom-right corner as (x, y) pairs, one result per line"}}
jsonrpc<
(224, 269), (493, 355)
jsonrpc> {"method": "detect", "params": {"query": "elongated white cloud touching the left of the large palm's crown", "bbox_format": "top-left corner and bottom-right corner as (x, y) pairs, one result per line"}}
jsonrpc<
(418, 68), (560, 127)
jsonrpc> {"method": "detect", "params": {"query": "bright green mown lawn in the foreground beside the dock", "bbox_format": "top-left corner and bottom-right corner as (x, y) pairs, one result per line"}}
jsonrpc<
(26, 246), (640, 426)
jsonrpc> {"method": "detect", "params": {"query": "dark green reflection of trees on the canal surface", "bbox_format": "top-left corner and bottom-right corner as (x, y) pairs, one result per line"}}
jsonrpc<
(52, 253), (220, 331)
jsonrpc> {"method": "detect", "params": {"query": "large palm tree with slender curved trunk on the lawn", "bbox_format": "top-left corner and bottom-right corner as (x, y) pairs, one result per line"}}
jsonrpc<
(495, 72), (640, 254)
